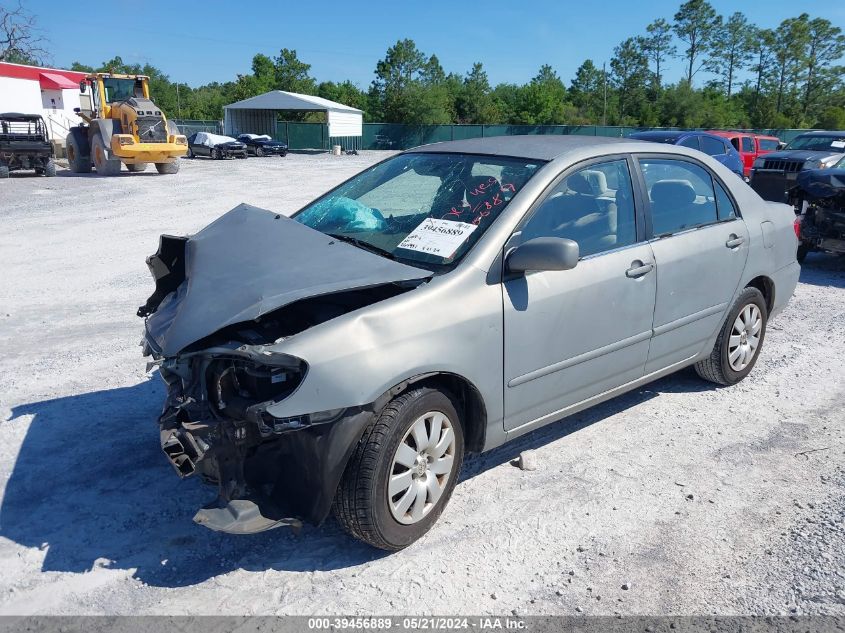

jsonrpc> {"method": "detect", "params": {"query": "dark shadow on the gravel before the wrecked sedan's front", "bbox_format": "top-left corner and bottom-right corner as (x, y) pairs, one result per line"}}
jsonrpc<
(0, 377), (385, 587)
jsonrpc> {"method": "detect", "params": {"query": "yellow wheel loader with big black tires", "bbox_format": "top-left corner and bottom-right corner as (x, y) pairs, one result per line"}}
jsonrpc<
(67, 73), (188, 176)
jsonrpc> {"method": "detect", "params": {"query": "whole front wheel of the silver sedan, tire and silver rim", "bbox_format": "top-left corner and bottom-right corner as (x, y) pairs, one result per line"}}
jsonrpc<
(334, 388), (464, 550)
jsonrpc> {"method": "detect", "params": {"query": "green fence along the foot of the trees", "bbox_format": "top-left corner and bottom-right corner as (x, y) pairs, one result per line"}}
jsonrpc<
(170, 119), (807, 150)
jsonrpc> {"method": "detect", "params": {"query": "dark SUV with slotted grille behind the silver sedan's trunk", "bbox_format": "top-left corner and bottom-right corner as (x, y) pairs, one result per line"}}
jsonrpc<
(751, 131), (845, 202)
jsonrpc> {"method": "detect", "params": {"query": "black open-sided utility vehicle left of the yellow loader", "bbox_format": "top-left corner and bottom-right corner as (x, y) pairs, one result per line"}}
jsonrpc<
(0, 112), (56, 178)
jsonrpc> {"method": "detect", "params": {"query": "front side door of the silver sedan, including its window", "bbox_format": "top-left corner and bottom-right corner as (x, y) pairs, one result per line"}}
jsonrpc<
(503, 157), (656, 431)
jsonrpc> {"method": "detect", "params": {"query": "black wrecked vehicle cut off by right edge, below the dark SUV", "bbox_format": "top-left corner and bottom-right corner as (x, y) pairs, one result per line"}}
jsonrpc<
(789, 156), (845, 262)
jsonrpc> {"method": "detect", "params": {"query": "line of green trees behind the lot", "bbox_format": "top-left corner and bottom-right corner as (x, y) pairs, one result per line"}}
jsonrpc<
(0, 0), (845, 129)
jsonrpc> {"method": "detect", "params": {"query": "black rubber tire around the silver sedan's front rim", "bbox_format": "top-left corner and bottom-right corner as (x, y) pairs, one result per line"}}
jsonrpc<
(334, 388), (464, 551)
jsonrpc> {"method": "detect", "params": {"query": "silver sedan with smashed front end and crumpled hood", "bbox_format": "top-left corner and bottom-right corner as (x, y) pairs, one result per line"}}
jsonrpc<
(139, 136), (799, 550)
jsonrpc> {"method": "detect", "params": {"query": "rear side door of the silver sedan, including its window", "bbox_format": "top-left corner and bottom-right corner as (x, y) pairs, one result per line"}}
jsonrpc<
(638, 154), (749, 374)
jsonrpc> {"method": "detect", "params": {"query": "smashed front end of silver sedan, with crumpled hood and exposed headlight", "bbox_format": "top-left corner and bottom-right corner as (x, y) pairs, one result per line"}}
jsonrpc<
(138, 205), (430, 534)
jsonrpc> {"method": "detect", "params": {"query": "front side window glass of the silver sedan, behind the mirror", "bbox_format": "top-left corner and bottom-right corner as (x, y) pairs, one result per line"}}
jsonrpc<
(522, 159), (637, 257)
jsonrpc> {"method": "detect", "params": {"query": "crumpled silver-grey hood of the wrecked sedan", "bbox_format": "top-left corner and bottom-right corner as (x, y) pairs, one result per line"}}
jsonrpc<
(146, 204), (432, 356)
